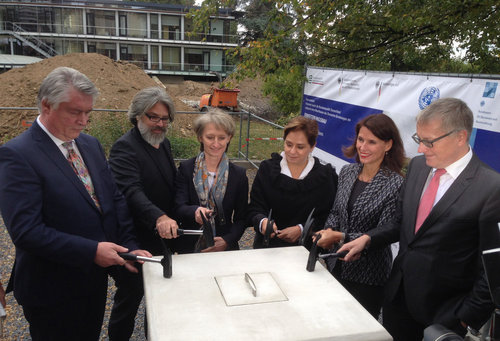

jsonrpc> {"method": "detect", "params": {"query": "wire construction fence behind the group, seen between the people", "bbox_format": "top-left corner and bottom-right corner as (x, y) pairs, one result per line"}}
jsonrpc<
(0, 107), (283, 168)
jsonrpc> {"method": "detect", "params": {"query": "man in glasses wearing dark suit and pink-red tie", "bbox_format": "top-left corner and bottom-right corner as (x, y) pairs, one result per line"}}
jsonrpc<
(339, 98), (500, 341)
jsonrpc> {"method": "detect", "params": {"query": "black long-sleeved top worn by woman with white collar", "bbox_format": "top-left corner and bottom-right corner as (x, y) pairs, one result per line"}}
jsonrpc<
(248, 153), (338, 247)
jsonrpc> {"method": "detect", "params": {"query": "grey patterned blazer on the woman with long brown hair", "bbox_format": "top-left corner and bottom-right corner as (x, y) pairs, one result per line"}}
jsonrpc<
(325, 163), (404, 285)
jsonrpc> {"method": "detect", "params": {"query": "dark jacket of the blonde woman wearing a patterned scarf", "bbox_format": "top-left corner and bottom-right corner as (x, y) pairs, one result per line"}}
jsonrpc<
(175, 158), (248, 253)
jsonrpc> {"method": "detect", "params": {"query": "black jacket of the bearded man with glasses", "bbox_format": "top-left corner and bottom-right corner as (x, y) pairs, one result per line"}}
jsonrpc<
(109, 127), (176, 255)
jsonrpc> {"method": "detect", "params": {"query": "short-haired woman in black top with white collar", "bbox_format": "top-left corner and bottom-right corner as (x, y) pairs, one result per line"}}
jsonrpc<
(249, 116), (337, 248)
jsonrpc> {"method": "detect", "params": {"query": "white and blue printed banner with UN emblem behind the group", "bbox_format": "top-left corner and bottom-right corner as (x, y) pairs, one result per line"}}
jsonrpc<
(302, 67), (500, 171)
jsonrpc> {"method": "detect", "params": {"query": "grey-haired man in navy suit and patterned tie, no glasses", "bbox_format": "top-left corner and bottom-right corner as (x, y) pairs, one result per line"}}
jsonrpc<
(0, 67), (150, 341)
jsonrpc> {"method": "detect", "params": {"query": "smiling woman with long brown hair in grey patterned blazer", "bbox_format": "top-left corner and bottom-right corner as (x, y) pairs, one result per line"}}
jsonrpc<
(318, 114), (404, 318)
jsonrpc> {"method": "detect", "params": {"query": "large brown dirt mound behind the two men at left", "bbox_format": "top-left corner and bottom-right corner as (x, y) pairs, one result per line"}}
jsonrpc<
(0, 53), (192, 141)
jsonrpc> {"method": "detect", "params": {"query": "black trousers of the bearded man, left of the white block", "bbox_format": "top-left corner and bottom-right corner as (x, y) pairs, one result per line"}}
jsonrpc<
(108, 264), (146, 341)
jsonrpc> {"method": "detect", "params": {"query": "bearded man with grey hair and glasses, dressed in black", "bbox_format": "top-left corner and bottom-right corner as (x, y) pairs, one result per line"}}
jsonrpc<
(108, 87), (178, 340)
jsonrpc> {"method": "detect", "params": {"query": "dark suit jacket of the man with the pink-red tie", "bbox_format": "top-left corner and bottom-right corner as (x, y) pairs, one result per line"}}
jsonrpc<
(367, 155), (500, 329)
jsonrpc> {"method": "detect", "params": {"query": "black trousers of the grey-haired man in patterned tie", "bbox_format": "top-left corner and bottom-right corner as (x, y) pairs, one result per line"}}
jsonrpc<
(23, 276), (108, 341)
